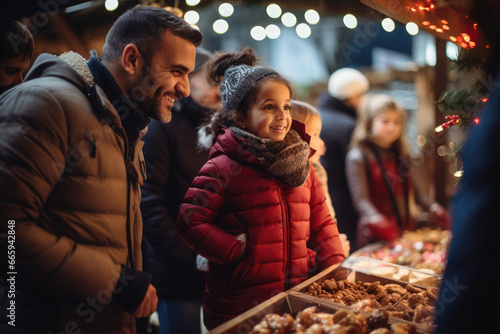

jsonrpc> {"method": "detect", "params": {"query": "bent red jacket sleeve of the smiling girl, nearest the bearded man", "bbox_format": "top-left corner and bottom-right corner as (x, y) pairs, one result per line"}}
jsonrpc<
(177, 161), (244, 265)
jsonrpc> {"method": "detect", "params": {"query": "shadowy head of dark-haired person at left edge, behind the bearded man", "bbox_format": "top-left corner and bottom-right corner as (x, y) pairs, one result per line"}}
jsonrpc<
(0, 21), (35, 95)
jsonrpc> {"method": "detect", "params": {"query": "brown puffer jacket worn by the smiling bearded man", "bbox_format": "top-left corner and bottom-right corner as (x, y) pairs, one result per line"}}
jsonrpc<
(0, 54), (145, 334)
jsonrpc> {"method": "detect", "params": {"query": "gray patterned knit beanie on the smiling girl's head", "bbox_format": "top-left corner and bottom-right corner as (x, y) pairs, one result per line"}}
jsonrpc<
(220, 65), (278, 115)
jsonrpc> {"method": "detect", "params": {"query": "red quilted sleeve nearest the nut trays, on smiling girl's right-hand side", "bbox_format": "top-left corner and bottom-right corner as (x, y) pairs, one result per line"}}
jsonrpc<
(308, 168), (345, 270)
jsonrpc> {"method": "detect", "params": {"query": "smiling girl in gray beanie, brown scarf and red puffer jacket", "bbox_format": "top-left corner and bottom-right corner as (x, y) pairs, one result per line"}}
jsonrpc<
(177, 49), (345, 330)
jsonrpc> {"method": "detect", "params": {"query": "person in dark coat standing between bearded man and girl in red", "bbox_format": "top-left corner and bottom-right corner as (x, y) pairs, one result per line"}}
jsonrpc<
(141, 47), (221, 334)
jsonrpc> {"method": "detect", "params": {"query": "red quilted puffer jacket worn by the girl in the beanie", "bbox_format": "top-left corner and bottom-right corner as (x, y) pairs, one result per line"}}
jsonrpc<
(177, 123), (344, 329)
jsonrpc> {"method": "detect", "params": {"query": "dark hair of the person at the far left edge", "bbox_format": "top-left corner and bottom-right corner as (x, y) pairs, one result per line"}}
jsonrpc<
(0, 21), (35, 63)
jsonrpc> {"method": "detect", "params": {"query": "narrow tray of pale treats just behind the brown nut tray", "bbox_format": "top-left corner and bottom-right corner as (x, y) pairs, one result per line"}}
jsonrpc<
(342, 256), (443, 287)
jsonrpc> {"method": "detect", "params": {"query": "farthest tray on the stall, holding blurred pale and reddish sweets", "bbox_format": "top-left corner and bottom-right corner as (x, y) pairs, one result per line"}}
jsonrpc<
(349, 227), (451, 275)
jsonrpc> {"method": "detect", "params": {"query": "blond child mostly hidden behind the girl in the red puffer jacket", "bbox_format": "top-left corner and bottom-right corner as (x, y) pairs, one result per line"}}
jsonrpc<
(291, 100), (350, 257)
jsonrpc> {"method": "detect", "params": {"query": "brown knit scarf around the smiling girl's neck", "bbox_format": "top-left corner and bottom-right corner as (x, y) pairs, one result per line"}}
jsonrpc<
(229, 126), (310, 188)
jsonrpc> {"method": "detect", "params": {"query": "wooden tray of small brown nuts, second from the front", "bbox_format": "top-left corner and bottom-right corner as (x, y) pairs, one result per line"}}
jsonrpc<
(292, 266), (439, 332)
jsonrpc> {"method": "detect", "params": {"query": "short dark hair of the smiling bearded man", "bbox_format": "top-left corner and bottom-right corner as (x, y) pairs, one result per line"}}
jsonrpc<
(102, 6), (202, 63)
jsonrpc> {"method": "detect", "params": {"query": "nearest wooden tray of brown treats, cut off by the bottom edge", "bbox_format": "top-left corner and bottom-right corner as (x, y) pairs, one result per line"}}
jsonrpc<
(210, 291), (429, 334)
